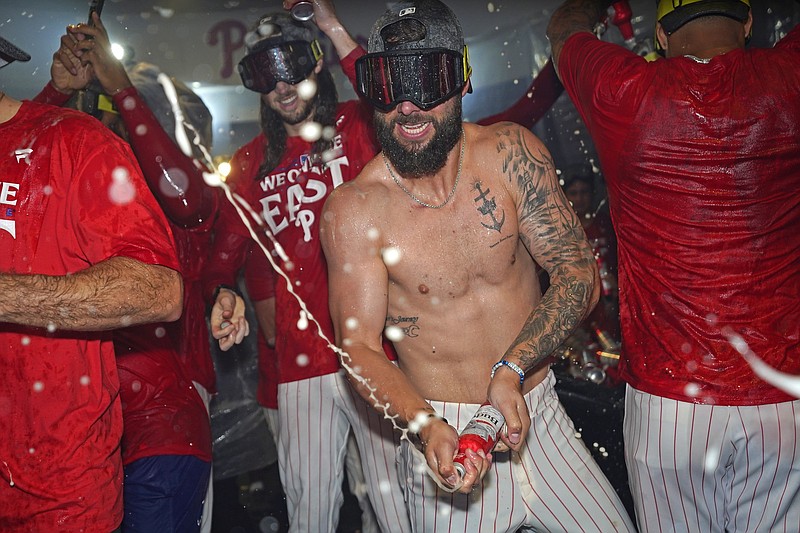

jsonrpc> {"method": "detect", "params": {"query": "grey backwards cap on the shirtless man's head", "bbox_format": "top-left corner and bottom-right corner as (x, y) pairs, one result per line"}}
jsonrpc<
(369, 0), (464, 54)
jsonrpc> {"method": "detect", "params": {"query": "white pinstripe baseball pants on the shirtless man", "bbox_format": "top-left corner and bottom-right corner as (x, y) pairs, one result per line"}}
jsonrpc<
(400, 372), (635, 533)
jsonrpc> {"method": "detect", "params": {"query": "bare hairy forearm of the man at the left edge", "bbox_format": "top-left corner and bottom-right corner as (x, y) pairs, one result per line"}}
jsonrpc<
(0, 257), (183, 331)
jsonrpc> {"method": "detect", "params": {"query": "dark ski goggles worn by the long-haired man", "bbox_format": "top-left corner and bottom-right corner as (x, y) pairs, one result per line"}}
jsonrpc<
(239, 39), (322, 94)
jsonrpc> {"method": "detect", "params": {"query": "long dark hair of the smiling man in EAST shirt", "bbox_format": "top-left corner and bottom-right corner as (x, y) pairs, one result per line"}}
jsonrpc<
(257, 67), (339, 180)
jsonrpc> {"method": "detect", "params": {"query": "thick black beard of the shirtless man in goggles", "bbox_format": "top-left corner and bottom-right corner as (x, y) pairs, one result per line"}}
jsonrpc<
(374, 96), (462, 178)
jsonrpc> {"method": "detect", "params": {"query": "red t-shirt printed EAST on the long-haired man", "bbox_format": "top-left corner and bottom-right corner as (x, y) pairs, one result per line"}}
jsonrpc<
(217, 95), (377, 383)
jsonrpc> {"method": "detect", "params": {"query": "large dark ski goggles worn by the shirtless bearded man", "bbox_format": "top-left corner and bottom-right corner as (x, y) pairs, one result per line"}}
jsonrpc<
(356, 46), (472, 111)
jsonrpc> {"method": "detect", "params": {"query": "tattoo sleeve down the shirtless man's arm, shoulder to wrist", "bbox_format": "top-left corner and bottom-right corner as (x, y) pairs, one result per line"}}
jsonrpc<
(498, 128), (594, 370)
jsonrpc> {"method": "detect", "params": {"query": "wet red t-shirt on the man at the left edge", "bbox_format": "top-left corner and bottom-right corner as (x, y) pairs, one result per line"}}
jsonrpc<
(0, 102), (178, 532)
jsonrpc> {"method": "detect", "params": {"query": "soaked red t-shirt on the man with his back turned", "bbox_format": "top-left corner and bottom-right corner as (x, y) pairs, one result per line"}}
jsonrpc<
(559, 27), (800, 405)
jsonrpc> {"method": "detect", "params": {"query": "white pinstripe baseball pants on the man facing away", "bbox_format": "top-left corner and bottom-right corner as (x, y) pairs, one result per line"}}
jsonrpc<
(623, 386), (800, 533)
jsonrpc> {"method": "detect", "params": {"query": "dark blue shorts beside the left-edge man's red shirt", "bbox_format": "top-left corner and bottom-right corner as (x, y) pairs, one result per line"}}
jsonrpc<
(122, 455), (211, 533)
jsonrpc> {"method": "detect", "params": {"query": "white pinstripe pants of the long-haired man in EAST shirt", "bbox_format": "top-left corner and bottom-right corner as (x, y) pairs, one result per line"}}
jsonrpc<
(278, 371), (411, 533)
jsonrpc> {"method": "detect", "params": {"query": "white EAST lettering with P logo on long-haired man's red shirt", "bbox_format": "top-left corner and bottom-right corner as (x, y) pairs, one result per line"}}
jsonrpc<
(261, 136), (350, 242)
